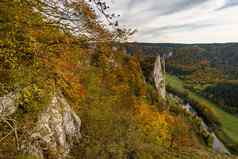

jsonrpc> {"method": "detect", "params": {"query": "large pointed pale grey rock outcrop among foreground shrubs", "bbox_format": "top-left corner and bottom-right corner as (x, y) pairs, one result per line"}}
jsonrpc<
(22, 92), (81, 159)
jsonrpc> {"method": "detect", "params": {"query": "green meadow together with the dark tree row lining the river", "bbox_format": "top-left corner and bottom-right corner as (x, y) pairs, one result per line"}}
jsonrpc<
(166, 75), (238, 154)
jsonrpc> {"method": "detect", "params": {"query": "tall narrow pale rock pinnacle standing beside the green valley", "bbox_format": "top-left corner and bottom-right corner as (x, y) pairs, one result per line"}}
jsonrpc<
(154, 55), (166, 99)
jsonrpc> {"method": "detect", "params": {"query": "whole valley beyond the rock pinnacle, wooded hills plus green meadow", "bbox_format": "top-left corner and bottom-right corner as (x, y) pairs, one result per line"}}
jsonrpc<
(136, 43), (238, 153)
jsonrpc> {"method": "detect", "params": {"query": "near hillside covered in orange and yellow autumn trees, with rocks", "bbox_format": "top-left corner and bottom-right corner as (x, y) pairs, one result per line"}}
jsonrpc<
(0, 0), (236, 159)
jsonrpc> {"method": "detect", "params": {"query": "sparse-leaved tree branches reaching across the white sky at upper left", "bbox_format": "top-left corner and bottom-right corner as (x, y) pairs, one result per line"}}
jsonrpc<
(21, 0), (135, 42)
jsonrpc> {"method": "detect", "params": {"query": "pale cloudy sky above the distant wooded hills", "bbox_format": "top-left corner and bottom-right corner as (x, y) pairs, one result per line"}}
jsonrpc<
(108, 0), (238, 43)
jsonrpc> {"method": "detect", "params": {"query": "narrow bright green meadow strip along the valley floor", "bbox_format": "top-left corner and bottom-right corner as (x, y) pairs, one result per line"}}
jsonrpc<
(166, 75), (238, 154)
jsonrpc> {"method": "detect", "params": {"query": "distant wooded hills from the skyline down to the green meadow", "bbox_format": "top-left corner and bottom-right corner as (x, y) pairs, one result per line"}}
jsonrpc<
(127, 43), (238, 115)
